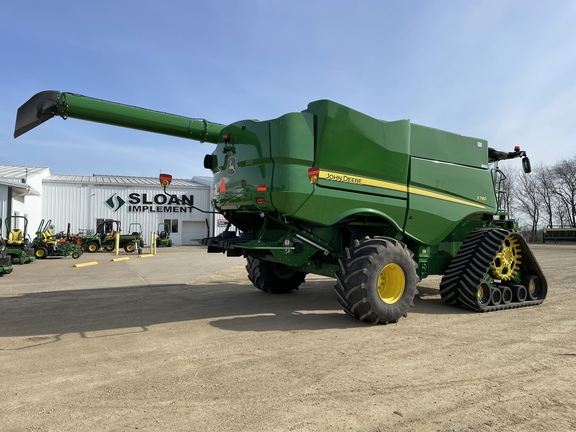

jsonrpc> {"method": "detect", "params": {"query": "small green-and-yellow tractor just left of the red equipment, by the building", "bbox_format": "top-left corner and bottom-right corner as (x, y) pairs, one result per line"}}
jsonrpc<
(32, 219), (82, 259)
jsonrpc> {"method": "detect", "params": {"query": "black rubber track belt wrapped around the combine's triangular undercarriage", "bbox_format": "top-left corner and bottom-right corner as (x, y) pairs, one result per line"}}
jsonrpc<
(440, 228), (547, 312)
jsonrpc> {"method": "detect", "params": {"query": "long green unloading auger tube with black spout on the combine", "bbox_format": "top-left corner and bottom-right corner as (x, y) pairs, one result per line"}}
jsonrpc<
(14, 90), (224, 144)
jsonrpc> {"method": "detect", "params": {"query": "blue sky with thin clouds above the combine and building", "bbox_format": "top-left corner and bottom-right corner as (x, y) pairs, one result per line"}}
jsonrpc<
(0, 0), (576, 178)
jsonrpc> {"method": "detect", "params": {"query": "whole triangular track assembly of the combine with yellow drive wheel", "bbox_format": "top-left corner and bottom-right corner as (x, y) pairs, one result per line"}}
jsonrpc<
(440, 228), (548, 312)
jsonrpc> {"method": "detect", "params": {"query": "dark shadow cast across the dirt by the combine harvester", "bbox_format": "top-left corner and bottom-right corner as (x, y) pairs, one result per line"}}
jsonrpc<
(0, 280), (470, 338)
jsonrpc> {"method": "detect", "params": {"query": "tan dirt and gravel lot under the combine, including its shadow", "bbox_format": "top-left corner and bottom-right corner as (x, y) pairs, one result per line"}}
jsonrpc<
(0, 245), (576, 432)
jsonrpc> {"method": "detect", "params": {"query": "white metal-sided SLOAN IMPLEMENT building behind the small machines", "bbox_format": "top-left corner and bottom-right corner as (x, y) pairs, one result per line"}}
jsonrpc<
(0, 165), (219, 245)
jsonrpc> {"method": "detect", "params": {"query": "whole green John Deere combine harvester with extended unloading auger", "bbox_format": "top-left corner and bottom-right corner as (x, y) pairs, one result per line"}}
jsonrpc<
(14, 91), (547, 323)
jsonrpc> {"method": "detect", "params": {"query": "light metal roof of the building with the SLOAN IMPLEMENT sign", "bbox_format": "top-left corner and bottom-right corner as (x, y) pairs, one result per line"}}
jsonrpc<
(43, 174), (211, 187)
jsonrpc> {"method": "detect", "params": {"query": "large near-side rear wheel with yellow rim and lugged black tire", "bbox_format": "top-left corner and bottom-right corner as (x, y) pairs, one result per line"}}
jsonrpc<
(336, 237), (419, 324)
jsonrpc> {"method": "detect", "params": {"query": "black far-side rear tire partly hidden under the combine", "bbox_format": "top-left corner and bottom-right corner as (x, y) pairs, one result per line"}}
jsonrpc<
(246, 257), (306, 294)
